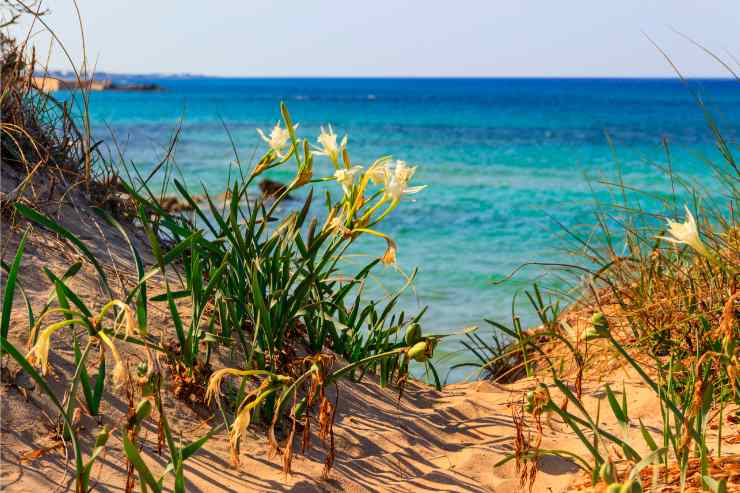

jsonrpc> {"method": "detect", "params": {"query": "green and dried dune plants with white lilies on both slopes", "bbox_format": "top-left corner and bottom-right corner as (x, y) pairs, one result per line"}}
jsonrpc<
(0, 4), (740, 493)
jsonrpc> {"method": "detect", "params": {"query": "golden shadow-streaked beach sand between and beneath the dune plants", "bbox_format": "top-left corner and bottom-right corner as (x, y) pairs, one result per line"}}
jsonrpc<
(0, 178), (740, 493)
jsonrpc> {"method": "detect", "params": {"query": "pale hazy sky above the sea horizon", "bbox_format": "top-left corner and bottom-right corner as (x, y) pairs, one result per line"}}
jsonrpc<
(8, 0), (740, 77)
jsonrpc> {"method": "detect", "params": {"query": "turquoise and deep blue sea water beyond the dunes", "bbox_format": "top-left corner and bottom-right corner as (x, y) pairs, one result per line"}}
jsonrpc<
(73, 78), (740, 376)
